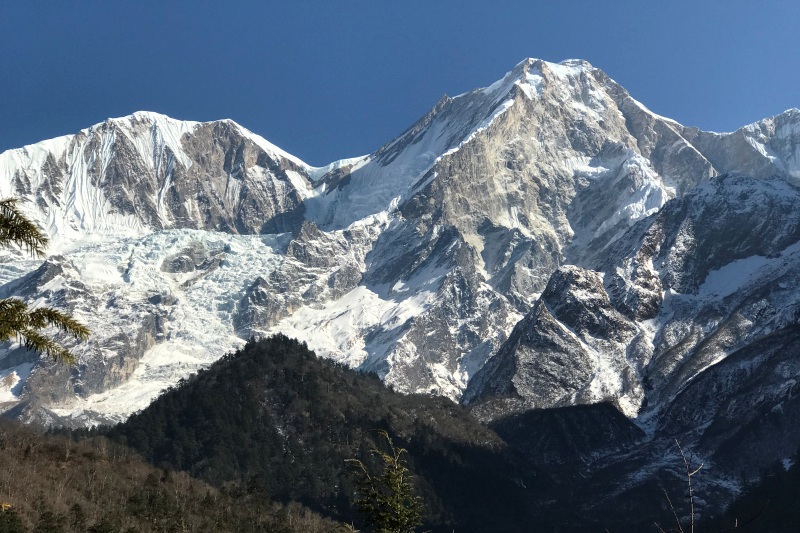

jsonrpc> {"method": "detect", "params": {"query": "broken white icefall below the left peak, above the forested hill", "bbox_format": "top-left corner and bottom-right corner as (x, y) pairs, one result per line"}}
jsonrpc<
(4, 229), (287, 424)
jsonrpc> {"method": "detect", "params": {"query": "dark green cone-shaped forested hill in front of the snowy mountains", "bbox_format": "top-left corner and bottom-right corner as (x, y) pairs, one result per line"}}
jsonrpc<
(109, 336), (553, 531)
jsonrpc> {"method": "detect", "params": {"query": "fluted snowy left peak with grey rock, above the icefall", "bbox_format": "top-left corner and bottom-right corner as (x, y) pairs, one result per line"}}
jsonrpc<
(0, 112), (312, 249)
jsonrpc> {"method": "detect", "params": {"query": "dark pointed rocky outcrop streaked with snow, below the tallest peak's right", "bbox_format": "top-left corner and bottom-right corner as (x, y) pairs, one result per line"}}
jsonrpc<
(464, 266), (642, 416)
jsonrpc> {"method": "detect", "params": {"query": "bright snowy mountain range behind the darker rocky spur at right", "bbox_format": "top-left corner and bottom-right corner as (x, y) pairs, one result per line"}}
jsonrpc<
(0, 59), (800, 432)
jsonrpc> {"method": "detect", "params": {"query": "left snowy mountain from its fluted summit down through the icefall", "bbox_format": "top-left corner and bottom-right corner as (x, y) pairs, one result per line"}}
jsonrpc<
(0, 113), (324, 420)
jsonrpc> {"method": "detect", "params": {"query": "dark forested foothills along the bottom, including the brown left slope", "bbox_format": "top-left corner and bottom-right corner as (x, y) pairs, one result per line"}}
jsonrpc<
(0, 335), (800, 533)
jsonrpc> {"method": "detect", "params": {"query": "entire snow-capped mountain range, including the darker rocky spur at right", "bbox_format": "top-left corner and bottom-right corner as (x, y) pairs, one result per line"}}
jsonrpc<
(0, 59), (800, 444)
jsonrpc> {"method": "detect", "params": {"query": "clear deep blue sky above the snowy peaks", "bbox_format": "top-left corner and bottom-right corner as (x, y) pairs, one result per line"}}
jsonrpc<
(0, 0), (800, 165)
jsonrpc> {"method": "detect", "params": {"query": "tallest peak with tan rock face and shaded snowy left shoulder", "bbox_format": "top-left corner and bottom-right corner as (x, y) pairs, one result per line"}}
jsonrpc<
(287, 60), (714, 397)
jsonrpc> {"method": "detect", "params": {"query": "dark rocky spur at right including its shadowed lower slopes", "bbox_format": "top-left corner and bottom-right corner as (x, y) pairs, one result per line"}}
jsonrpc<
(464, 176), (800, 505)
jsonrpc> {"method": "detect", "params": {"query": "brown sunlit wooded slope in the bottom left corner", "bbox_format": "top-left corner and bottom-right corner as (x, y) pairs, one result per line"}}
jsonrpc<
(0, 420), (336, 533)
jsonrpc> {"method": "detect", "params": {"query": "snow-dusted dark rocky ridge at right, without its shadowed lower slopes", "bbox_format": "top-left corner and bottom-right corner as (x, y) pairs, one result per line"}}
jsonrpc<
(466, 176), (800, 416)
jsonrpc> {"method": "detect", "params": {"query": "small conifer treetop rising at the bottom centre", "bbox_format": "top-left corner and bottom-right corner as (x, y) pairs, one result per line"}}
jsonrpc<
(347, 430), (422, 533)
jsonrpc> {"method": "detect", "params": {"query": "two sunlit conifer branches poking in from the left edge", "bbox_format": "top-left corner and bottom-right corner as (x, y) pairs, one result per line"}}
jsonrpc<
(0, 198), (89, 364)
